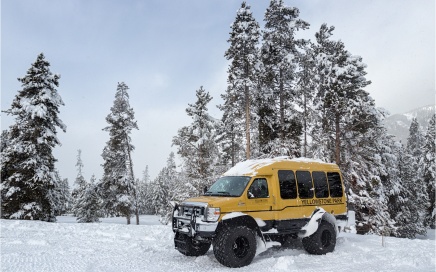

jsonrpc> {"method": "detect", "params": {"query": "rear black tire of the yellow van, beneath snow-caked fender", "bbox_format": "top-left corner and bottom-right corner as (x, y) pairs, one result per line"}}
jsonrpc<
(302, 221), (336, 255)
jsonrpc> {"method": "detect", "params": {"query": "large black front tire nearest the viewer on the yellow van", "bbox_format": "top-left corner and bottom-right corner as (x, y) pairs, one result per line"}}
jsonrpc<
(213, 226), (257, 267)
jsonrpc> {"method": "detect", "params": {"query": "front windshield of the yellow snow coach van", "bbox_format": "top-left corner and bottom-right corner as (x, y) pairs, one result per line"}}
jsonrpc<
(204, 177), (251, 196)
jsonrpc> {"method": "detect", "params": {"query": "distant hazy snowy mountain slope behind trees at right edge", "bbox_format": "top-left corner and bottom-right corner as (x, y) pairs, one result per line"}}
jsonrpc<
(384, 105), (435, 144)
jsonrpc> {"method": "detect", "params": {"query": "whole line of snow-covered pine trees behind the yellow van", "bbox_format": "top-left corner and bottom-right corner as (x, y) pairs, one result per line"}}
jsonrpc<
(1, 0), (436, 237)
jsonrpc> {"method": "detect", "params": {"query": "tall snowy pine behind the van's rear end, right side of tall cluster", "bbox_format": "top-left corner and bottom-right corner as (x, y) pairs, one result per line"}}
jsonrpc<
(312, 24), (395, 233)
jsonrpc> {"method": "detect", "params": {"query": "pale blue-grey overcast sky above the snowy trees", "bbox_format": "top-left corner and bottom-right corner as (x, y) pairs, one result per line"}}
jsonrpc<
(1, 0), (435, 184)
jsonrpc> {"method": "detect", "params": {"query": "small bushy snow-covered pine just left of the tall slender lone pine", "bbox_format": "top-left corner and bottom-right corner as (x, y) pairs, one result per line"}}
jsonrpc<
(75, 175), (100, 223)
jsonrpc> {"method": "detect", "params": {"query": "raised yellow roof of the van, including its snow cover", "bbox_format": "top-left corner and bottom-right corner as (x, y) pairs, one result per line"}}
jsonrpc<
(224, 157), (339, 176)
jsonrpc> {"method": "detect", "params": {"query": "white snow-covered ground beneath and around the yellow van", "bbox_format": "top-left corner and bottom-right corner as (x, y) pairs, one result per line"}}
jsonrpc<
(0, 216), (435, 272)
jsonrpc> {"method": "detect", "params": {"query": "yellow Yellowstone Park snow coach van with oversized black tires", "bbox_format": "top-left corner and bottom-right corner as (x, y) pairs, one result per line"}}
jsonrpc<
(172, 157), (348, 267)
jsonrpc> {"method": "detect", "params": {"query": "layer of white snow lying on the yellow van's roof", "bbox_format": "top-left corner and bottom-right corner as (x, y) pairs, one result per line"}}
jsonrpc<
(224, 157), (333, 176)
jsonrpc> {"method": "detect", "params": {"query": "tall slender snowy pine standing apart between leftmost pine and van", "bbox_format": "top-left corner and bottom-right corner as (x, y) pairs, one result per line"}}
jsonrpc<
(98, 82), (138, 224)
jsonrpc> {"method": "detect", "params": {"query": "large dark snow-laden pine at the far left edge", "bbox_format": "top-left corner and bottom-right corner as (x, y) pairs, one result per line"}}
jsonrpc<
(1, 53), (66, 221)
